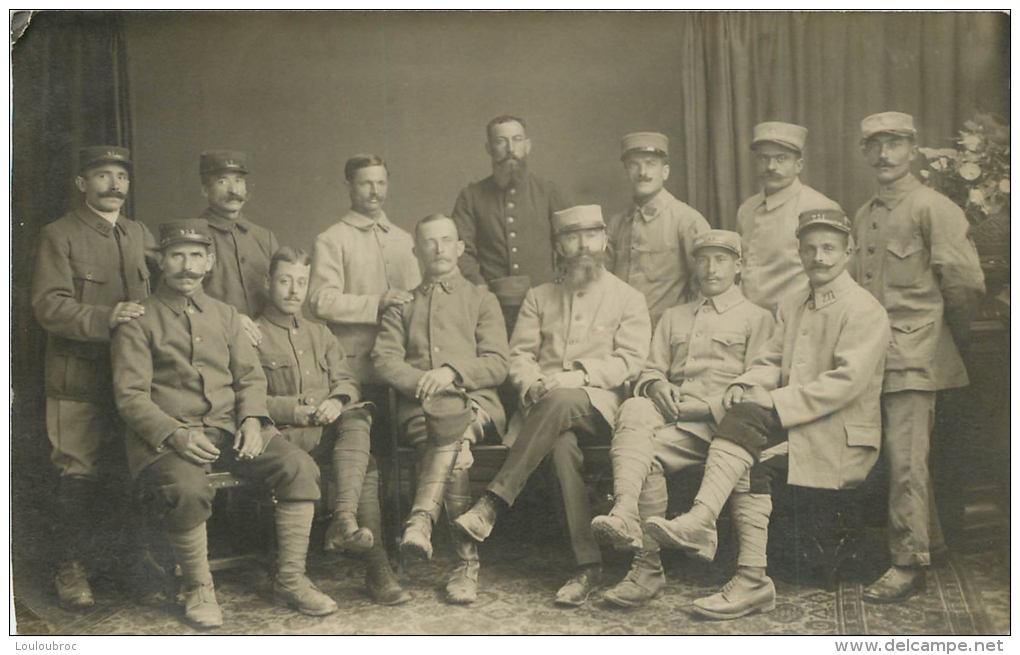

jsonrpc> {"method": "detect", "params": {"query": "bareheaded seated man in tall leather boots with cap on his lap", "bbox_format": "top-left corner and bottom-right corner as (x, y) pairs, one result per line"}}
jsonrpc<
(372, 214), (508, 604)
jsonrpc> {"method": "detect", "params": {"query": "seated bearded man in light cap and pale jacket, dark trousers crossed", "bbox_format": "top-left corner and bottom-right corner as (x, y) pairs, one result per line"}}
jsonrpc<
(455, 205), (652, 607)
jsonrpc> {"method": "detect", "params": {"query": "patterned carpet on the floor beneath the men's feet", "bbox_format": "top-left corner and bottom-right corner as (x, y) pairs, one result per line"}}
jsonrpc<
(15, 518), (1010, 635)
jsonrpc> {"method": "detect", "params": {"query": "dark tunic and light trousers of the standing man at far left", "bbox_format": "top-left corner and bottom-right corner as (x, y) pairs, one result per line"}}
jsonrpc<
(32, 205), (155, 477)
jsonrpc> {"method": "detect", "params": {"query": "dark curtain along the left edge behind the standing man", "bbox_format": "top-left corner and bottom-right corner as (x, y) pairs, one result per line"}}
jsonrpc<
(10, 11), (131, 571)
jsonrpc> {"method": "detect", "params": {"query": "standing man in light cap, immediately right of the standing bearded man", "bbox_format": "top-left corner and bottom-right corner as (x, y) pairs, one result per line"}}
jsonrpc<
(606, 132), (709, 328)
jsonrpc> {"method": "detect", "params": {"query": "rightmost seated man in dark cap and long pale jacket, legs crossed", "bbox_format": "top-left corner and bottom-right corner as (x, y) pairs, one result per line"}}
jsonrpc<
(645, 209), (891, 619)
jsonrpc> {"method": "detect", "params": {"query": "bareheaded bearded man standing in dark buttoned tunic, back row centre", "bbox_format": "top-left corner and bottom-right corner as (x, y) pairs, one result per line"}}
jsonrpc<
(452, 115), (568, 334)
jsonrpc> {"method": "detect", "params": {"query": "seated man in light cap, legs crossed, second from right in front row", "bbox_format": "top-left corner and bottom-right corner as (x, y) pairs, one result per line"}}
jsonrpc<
(592, 230), (775, 607)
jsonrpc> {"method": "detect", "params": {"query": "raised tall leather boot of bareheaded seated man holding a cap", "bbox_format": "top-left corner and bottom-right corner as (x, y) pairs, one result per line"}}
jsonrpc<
(400, 433), (463, 560)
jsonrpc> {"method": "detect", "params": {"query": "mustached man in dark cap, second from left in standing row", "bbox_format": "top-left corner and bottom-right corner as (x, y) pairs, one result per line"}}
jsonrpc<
(199, 150), (279, 346)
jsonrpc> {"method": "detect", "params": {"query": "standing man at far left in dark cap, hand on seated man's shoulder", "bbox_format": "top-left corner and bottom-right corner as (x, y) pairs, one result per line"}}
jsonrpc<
(32, 146), (156, 608)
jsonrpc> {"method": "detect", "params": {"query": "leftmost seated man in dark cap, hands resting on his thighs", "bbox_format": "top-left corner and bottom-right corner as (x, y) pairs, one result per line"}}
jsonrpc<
(111, 218), (337, 627)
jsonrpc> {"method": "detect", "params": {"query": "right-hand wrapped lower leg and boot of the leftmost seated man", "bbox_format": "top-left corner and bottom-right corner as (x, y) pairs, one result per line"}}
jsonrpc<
(272, 502), (337, 616)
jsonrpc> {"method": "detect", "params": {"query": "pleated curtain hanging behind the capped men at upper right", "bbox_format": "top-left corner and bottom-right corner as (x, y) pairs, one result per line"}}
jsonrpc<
(677, 12), (1009, 230)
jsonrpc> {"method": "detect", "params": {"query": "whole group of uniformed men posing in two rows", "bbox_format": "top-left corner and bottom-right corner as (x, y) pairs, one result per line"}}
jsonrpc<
(32, 112), (983, 627)
